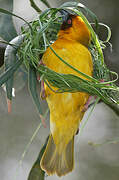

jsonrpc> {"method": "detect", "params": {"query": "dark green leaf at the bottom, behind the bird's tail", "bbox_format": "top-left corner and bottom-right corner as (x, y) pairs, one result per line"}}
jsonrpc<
(28, 137), (49, 180)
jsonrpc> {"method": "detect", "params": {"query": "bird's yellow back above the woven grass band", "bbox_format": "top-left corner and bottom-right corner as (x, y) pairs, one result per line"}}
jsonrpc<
(43, 39), (93, 76)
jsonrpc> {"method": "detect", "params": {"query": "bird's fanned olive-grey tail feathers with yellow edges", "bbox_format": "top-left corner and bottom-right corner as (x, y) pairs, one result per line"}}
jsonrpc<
(40, 135), (74, 176)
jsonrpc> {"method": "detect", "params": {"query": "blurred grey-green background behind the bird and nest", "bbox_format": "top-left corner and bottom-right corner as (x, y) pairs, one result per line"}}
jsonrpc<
(0, 0), (119, 180)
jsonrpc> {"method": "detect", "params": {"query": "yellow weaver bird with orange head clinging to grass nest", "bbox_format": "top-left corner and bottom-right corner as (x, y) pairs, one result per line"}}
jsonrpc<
(40, 11), (93, 176)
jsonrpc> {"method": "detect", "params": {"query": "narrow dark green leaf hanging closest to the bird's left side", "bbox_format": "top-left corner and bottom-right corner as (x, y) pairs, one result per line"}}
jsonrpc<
(28, 65), (43, 115)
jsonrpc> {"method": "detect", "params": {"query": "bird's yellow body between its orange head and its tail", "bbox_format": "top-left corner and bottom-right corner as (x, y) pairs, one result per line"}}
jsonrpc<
(42, 38), (93, 144)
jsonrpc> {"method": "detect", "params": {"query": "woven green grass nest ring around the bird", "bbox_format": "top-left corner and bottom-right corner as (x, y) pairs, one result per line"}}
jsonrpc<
(18, 3), (119, 107)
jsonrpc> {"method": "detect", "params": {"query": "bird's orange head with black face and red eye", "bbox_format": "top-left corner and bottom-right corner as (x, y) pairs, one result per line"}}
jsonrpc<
(58, 10), (91, 46)
